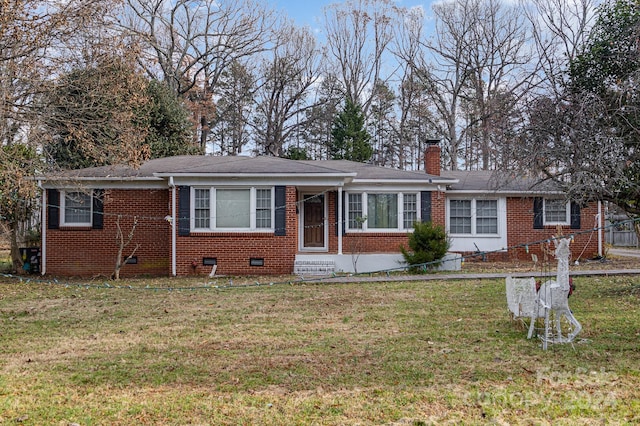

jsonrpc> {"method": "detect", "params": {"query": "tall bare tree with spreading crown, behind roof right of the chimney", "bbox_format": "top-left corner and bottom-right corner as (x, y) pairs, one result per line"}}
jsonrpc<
(458, 0), (539, 170)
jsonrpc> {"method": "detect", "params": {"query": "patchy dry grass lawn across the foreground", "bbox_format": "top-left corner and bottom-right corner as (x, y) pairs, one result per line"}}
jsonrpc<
(0, 277), (640, 425)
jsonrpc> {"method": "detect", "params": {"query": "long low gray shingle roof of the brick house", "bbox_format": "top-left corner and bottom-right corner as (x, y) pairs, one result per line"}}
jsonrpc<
(43, 155), (560, 194)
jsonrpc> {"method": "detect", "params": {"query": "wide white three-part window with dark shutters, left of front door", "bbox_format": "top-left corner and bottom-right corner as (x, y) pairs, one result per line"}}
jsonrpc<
(190, 187), (275, 231)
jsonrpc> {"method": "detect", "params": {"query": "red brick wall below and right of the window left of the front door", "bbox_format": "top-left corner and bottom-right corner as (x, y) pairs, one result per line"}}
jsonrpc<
(176, 187), (298, 275)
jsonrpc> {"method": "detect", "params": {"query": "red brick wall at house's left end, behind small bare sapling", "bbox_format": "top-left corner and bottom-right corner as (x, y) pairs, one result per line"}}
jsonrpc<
(46, 190), (171, 277)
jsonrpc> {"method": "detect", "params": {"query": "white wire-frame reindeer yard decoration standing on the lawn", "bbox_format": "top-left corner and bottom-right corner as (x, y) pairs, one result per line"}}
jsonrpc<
(506, 238), (582, 350)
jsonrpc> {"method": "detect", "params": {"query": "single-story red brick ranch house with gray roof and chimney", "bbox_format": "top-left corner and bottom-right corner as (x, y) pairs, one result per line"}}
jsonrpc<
(38, 146), (602, 277)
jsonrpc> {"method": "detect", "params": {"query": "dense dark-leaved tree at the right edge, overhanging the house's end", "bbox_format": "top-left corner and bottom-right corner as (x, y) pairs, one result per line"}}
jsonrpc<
(522, 0), (640, 230)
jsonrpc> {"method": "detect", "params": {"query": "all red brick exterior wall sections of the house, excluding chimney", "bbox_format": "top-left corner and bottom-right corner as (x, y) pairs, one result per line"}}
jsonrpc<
(46, 187), (598, 277)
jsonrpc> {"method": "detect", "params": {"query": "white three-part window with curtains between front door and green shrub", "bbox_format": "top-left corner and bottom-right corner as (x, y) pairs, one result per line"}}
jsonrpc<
(346, 192), (419, 231)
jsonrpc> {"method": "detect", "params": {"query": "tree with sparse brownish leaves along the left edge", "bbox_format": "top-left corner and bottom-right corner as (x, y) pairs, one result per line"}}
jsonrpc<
(0, 0), (113, 265)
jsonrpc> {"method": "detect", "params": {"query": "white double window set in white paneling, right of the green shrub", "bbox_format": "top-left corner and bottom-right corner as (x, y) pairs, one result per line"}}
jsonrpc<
(448, 198), (499, 235)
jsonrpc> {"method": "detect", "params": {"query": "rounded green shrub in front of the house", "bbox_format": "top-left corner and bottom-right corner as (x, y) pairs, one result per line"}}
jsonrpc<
(400, 222), (450, 273)
